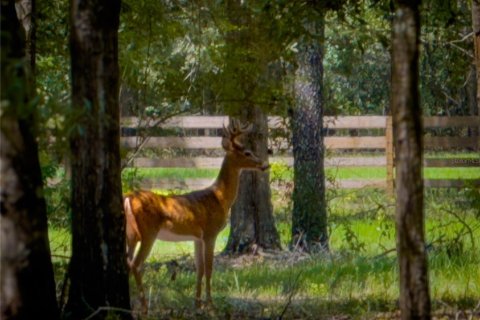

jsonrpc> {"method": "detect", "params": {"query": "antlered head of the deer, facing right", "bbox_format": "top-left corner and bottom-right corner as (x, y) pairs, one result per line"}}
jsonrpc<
(222, 119), (269, 171)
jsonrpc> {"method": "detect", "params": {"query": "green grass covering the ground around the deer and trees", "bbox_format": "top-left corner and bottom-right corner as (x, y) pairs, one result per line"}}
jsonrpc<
(50, 189), (480, 319)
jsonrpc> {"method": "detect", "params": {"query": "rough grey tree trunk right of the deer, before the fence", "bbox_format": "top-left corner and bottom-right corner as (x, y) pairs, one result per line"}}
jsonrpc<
(291, 16), (328, 252)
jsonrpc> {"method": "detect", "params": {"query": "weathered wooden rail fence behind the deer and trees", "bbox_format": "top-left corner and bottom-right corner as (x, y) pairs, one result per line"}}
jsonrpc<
(121, 116), (480, 192)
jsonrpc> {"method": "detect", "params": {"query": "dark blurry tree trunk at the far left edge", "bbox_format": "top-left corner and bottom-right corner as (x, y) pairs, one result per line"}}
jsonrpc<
(0, 0), (59, 319)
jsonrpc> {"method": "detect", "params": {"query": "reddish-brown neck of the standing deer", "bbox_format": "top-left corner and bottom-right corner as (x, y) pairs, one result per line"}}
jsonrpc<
(213, 155), (241, 210)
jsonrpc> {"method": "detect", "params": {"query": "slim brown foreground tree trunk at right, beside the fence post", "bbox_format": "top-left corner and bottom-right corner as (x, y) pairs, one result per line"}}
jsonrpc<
(392, 1), (430, 319)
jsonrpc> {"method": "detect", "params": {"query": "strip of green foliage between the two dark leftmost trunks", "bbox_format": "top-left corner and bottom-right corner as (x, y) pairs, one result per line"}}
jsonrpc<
(36, 0), (74, 232)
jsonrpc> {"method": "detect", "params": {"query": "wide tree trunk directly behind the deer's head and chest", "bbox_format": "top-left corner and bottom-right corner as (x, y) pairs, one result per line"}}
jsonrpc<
(225, 106), (280, 253)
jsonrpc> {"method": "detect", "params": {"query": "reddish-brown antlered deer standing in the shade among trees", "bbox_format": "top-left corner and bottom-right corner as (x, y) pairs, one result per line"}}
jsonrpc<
(124, 119), (269, 313)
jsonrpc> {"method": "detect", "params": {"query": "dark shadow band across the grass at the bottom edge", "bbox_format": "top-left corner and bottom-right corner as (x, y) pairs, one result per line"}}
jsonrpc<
(133, 292), (480, 320)
